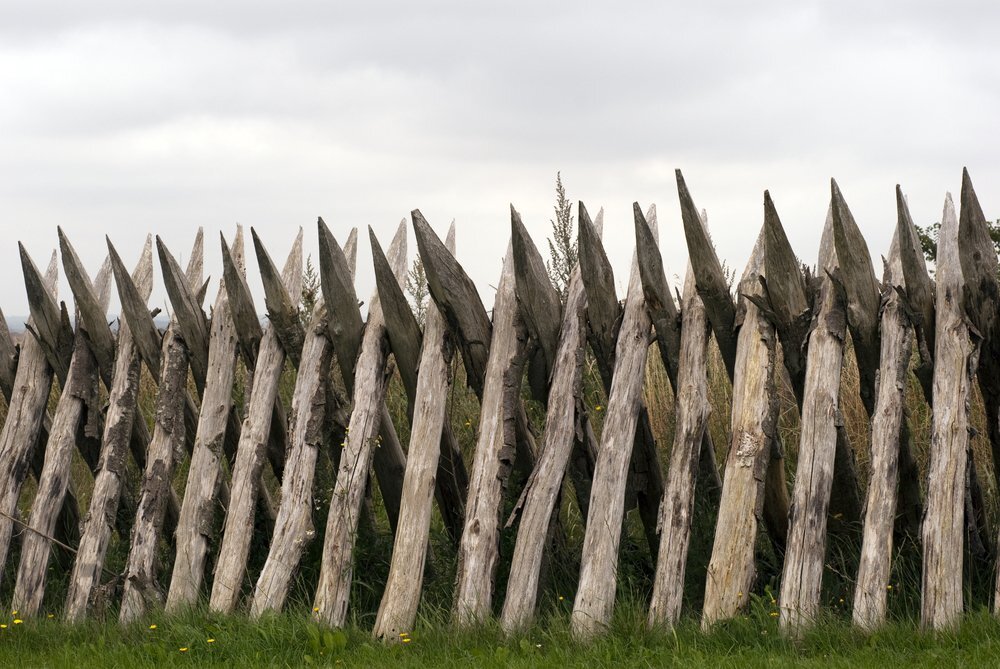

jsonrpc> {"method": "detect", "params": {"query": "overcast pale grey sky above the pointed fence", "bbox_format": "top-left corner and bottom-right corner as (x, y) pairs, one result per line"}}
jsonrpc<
(0, 0), (1000, 314)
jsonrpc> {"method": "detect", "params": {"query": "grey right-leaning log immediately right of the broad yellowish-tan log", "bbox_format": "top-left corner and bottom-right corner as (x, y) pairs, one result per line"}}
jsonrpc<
(779, 205), (847, 636)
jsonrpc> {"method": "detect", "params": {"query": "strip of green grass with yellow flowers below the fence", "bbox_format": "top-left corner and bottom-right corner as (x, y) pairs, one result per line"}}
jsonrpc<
(0, 599), (1000, 669)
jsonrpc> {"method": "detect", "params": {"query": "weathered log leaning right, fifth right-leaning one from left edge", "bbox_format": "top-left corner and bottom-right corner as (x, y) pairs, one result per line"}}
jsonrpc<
(165, 226), (244, 611)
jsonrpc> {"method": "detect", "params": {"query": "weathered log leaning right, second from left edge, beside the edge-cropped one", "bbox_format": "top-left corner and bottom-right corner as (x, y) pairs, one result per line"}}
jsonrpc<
(12, 262), (110, 618)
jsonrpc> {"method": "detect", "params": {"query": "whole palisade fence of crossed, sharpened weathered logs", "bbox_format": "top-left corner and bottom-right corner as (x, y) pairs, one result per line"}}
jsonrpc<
(0, 171), (1000, 640)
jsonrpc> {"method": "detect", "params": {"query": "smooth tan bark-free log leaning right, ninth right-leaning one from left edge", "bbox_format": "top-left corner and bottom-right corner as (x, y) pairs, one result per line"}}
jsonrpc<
(372, 224), (464, 641)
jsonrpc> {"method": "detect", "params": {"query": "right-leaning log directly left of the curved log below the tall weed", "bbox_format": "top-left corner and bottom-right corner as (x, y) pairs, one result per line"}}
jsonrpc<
(453, 237), (527, 626)
